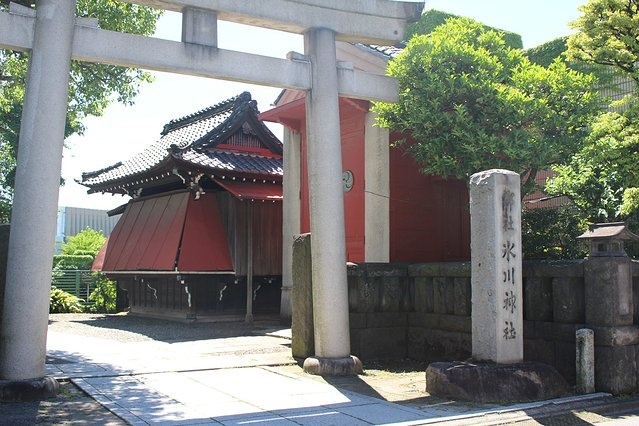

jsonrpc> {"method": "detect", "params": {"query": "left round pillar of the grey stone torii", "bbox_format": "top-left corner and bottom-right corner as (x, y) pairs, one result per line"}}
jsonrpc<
(0, 0), (75, 388)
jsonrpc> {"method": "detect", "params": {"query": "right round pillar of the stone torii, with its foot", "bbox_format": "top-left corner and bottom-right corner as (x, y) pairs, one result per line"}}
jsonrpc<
(304, 28), (362, 374)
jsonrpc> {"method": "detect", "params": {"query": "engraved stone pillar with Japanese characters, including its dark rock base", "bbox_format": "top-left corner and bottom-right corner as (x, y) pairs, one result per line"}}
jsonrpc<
(426, 170), (567, 402)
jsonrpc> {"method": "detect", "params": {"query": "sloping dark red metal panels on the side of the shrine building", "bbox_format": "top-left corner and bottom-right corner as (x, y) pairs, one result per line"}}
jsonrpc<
(93, 191), (233, 273)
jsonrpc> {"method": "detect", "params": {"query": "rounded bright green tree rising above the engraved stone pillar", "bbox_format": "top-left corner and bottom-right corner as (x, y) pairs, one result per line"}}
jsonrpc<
(374, 18), (598, 193)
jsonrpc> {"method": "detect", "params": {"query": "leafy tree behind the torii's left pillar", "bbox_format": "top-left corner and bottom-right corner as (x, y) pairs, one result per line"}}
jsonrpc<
(0, 0), (161, 222)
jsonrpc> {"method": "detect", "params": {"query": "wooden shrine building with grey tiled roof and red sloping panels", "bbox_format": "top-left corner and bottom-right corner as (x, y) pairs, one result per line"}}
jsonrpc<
(84, 92), (283, 320)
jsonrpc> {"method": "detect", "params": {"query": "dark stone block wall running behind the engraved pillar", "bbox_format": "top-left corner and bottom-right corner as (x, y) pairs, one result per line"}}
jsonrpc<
(348, 258), (639, 394)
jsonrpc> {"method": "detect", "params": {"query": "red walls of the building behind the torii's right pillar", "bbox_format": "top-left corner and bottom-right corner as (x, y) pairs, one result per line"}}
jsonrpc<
(266, 98), (470, 262)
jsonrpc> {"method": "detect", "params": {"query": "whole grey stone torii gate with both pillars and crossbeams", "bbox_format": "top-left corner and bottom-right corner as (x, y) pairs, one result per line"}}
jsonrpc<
(0, 0), (424, 390)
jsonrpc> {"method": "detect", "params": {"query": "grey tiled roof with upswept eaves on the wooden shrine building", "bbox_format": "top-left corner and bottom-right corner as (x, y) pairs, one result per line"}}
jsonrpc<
(79, 92), (282, 190)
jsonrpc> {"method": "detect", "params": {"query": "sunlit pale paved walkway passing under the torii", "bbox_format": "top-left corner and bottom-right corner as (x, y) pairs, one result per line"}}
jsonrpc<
(36, 324), (624, 425)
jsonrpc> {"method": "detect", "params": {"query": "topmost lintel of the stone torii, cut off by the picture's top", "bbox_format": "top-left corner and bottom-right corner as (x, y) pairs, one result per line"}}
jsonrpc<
(123, 0), (424, 44)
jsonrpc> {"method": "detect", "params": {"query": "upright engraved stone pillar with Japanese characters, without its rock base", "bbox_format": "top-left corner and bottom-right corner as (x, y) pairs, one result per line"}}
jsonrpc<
(470, 170), (524, 364)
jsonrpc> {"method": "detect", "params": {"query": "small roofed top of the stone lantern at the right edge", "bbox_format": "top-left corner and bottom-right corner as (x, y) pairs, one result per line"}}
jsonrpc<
(577, 222), (639, 257)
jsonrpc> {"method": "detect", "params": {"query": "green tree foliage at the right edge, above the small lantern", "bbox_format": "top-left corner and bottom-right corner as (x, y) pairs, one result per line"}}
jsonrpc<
(548, 0), (639, 221)
